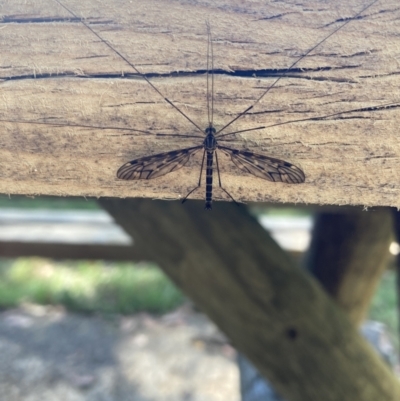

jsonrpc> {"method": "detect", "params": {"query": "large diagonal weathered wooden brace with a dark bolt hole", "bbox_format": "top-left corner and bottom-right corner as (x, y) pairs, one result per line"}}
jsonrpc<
(100, 199), (400, 401)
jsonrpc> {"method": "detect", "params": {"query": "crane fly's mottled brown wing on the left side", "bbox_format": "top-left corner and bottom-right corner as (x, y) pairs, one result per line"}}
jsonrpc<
(117, 145), (203, 180)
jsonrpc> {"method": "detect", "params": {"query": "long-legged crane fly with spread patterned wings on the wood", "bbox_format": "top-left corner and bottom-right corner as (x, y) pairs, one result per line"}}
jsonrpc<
(4, 0), (379, 210)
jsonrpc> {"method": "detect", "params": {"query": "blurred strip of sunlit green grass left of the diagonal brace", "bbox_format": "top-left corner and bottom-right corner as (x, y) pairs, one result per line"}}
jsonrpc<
(0, 258), (184, 314)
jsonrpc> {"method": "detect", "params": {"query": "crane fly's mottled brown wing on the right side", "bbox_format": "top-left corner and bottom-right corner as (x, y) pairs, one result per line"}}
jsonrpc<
(218, 145), (306, 184)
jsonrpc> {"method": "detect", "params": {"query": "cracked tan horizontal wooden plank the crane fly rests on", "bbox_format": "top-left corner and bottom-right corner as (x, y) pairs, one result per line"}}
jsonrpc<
(0, 0), (400, 206)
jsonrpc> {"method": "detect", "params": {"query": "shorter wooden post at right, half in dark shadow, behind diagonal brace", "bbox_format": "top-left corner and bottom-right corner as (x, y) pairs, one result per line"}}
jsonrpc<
(305, 209), (393, 326)
